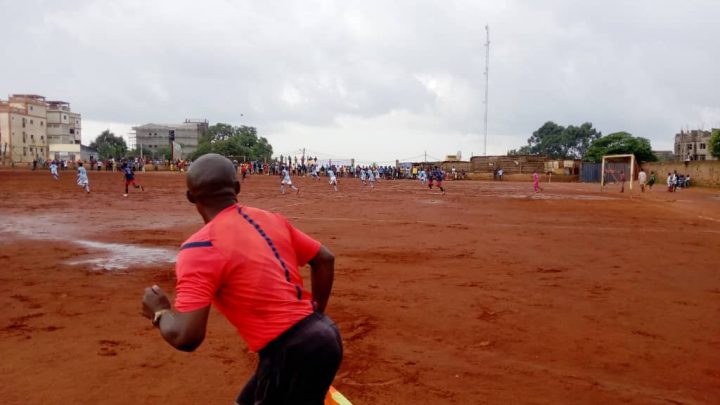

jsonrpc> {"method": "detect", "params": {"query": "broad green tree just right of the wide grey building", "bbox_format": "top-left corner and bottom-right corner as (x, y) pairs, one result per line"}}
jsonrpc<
(190, 123), (272, 160)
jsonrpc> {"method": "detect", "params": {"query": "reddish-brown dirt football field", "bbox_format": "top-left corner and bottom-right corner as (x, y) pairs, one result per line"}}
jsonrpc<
(0, 171), (720, 405)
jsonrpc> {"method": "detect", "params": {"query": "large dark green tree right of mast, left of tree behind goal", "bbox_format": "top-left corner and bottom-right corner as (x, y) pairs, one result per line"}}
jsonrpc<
(508, 121), (602, 159)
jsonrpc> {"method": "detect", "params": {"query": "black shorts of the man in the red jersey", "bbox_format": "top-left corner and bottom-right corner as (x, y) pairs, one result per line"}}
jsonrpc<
(237, 312), (343, 405)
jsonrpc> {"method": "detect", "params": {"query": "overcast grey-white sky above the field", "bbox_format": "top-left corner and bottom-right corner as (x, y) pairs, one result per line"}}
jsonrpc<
(0, 0), (720, 162)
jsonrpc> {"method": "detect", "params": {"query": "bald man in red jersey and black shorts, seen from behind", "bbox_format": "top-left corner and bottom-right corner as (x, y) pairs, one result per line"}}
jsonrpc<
(143, 154), (343, 405)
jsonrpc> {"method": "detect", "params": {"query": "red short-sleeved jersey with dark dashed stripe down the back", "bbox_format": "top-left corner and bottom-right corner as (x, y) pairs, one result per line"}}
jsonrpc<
(175, 204), (320, 352)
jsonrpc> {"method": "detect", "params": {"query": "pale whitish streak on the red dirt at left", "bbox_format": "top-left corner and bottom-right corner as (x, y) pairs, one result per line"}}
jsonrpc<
(0, 215), (177, 270)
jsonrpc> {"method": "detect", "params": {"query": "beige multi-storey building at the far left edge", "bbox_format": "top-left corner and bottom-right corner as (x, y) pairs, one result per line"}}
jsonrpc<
(0, 94), (48, 163)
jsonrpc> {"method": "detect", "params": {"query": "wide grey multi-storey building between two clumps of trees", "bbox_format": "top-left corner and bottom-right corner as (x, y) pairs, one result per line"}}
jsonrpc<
(133, 119), (208, 157)
